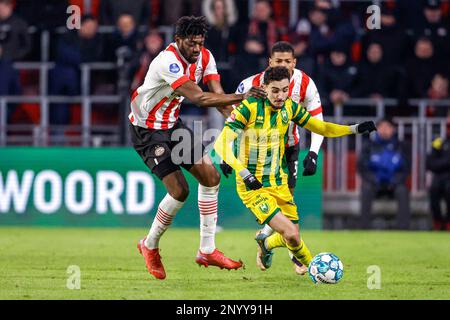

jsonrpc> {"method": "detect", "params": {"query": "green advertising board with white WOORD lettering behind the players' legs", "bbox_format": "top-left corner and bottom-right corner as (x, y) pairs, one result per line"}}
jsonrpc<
(0, 148), (322, 229)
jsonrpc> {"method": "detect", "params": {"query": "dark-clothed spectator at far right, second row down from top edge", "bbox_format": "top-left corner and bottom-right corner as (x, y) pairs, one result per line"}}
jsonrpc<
(406, 38), (442, 98)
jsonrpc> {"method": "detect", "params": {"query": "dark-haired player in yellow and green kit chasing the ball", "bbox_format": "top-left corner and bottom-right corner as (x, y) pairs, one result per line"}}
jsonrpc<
(214, 67), (376, 270)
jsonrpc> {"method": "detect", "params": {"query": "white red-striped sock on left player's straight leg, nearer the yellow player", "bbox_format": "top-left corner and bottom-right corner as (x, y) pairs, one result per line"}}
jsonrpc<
(198, 184), (219, 254)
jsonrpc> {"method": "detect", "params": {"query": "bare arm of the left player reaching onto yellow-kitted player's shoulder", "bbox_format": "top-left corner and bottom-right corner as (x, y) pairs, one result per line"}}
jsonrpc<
(175, 81), (267, 107)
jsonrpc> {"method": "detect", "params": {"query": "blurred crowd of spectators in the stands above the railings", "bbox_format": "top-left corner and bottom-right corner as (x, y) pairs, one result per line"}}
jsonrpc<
(0, 0), (450, 124)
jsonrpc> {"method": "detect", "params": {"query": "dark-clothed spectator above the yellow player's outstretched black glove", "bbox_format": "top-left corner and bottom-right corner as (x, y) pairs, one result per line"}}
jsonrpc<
(352, 42), (405, 99)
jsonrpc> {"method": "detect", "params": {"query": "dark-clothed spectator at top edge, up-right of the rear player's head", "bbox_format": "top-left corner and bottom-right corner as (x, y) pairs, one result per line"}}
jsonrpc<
(308, 1), (356, 55)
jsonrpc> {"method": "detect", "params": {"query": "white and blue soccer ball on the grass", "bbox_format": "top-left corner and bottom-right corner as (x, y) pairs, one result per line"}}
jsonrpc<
(308, 252), (344, 284)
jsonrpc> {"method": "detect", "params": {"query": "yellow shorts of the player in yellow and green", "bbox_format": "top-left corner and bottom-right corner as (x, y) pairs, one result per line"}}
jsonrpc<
(238, 185), (298, 224)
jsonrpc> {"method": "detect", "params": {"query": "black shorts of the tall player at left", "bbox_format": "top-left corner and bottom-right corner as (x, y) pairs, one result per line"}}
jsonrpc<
(129, 119), (205, 180)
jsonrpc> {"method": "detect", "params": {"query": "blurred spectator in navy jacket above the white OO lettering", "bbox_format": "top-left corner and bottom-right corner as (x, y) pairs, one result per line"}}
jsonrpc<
(49, 15), (103, 124)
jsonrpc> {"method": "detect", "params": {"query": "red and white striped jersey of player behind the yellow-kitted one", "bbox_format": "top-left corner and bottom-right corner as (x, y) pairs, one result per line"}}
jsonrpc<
(236, 69), (322, 147)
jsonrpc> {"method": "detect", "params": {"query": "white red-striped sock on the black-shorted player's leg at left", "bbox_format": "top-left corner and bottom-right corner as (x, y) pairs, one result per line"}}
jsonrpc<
(145, 194), (184, 249)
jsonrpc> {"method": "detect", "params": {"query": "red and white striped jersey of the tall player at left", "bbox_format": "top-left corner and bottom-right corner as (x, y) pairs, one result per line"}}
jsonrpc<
(128, 43), (220, 130)
